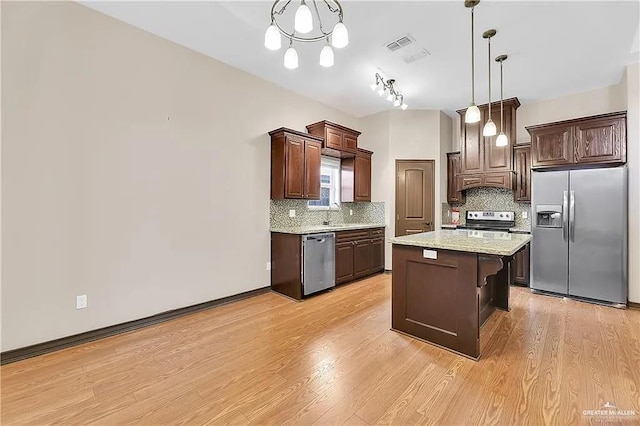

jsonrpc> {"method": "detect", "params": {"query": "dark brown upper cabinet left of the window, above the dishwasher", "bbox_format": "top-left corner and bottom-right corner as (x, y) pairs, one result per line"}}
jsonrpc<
(269, 128), (324, 200)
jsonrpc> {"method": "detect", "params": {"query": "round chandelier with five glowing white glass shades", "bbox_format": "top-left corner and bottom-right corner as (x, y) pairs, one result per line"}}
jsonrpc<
(264, 0), (349, 69)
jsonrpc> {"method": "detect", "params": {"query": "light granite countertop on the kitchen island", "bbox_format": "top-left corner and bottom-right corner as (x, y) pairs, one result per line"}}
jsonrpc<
(389, 229), (531, 256)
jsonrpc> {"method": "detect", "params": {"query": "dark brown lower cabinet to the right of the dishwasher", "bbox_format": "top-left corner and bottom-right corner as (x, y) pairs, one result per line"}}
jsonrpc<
(336, 228), (384, 284)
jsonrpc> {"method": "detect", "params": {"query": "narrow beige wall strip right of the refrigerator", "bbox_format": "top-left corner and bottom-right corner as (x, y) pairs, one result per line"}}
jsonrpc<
(626, 62), (640, 303)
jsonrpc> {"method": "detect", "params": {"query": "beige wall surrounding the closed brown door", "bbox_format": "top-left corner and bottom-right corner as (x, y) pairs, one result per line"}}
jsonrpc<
(359, 110), (451, 269)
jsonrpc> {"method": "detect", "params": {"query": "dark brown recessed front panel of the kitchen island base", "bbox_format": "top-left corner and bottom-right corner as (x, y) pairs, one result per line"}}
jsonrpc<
(391, 245), (480, 359)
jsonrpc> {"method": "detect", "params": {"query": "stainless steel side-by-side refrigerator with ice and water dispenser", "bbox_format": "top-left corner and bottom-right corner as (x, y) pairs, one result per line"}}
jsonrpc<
(530, 167), (628, 306)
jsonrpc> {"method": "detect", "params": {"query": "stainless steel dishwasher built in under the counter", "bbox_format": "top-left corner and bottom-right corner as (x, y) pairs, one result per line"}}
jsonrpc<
(302, 232), (336, 296)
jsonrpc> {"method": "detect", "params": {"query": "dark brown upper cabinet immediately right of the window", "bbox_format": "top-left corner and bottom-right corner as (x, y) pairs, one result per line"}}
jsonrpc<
(340, 148), (373, 203)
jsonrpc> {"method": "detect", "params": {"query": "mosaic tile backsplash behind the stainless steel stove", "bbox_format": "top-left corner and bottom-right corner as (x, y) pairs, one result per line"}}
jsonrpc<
(442, 188), (531, 228)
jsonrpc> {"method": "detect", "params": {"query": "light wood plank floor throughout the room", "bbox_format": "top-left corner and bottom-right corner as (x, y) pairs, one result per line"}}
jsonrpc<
(1, 275), (640, 425)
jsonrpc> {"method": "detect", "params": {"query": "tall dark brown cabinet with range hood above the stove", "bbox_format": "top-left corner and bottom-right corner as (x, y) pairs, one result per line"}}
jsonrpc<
(458, 98), (520, 191)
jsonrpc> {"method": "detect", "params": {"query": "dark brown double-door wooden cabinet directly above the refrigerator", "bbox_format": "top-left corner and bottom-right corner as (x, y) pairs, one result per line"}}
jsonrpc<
(527, 112), (627, 169)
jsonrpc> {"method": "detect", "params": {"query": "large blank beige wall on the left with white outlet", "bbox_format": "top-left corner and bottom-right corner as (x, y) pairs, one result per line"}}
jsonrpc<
(2, 2), (360, 351)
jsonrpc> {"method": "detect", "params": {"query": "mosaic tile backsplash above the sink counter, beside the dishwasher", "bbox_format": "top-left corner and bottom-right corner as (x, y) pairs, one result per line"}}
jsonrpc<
(270, 200), (384, 228)
